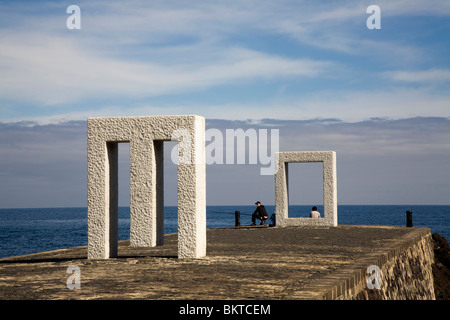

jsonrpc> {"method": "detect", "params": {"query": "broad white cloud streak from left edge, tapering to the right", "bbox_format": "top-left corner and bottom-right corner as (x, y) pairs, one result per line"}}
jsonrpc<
(0, 29), (333, 105)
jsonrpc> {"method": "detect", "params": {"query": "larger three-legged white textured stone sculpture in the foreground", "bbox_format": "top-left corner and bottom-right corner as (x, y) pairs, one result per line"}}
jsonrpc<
(88, 116), (206, 259)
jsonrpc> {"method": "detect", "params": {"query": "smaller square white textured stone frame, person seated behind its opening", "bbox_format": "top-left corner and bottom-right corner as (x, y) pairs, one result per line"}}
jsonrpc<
(275, 151), (337, 227)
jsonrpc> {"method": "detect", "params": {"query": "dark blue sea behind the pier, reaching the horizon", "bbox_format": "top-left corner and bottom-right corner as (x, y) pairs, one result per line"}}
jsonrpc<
(0, 205), (450, 257)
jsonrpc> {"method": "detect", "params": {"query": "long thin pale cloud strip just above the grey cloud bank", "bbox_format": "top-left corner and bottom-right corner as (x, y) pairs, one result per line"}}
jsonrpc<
(3, 85), (450, 124)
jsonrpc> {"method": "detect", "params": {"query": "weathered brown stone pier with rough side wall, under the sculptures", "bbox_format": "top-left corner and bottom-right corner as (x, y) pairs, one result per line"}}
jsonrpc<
(0, 225), (434, 300)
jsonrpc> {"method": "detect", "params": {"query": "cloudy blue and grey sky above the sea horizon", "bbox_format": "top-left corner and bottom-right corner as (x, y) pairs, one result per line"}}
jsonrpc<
(0, 0), (450, 208)
